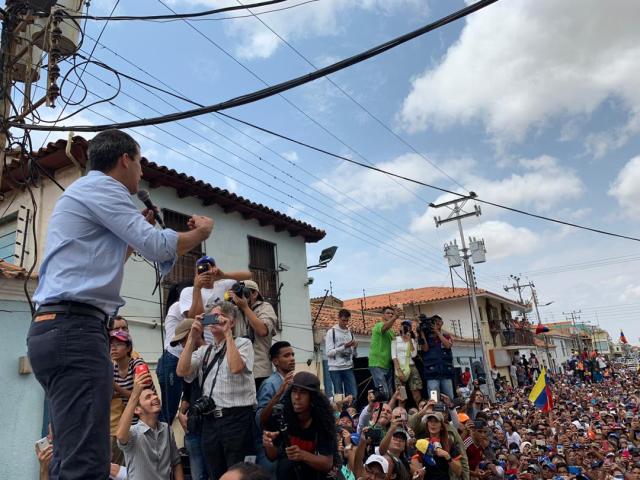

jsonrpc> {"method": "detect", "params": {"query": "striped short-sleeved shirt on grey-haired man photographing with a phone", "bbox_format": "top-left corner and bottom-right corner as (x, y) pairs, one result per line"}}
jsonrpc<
(185, 337), (256, 408)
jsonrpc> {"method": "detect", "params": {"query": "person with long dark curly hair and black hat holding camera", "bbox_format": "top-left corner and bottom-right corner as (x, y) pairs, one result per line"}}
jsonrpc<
(262, 372), (338, 480)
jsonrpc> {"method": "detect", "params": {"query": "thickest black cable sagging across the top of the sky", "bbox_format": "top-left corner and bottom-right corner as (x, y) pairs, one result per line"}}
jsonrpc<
(9, 0), (498, 132)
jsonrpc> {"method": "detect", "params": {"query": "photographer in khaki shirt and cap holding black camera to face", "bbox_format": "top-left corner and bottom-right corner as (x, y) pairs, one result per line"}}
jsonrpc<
(230, 280), (278, 390)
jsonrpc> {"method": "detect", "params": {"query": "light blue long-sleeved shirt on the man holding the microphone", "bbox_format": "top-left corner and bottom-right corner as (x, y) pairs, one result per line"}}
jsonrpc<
(33, 170), (178, 315)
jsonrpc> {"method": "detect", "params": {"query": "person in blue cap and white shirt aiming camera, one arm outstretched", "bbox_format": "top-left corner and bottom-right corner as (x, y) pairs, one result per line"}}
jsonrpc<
(180, 255), (251, 318)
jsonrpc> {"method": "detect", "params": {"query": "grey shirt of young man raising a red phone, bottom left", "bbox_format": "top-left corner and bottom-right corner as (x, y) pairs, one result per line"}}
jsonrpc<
(118, 421), (180, 480)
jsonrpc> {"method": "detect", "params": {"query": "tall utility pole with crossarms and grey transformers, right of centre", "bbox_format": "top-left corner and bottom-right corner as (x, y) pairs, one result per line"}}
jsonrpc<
(429, 192), (496, 402)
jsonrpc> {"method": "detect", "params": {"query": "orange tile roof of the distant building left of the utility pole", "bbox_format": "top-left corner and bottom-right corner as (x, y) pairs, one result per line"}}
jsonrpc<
(344, 287), (486, 310)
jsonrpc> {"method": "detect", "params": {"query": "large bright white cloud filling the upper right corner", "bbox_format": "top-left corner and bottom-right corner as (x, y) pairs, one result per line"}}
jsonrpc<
(400, 0), (640, 149)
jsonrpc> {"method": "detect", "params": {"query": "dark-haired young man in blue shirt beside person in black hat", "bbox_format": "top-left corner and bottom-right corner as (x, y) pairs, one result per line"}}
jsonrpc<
(256, 341), (296, 478)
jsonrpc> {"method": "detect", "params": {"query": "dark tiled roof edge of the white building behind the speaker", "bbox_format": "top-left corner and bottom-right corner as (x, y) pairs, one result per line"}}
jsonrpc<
(0, 136), (326, 242)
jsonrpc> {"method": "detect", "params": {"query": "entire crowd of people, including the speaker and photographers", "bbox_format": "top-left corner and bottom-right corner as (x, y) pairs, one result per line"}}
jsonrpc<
(27, 130), (640, 480)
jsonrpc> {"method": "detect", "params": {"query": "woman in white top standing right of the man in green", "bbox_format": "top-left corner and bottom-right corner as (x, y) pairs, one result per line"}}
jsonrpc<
(391, 320), (422, 405)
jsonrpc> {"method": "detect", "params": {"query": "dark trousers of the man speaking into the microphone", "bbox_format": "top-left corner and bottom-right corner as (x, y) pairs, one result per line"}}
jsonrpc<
(27, 314), (113, 480)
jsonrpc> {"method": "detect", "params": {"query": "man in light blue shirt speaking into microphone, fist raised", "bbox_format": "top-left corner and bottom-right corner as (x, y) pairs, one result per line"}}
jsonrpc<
(27, 130), (213, 480)
